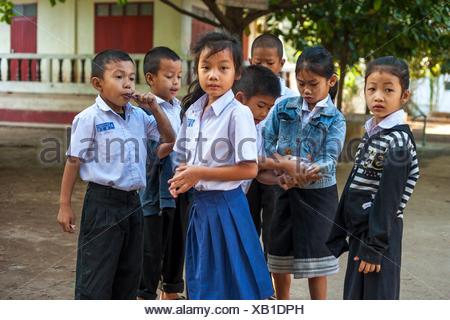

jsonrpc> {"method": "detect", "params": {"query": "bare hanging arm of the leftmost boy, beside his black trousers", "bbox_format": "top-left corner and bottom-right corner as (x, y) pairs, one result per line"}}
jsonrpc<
(57, 157), (80, 233)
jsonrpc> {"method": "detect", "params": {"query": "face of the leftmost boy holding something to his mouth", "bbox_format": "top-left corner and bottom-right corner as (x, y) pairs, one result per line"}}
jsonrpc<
(92, 61), (136, 112)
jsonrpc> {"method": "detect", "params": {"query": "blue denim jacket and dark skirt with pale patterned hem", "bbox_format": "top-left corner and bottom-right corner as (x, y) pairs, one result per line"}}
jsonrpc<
(263, 96), (345, 278)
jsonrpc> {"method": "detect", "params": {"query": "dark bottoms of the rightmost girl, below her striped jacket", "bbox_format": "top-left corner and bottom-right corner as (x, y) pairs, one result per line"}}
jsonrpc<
(344, 218), (403, 300)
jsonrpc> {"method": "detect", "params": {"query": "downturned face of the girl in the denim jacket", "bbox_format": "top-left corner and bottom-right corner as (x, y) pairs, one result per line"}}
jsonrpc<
(295, 70), (337, 106)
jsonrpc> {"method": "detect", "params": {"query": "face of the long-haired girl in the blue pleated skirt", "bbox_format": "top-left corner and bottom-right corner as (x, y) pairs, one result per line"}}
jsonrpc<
(197, 49), (238, 104)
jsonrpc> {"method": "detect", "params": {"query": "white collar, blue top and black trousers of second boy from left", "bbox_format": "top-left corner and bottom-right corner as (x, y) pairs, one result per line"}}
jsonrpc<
(138, 96), (188, 300)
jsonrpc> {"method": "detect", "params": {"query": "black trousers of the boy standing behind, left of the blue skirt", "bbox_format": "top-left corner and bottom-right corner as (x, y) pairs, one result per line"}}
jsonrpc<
(138, 195), (188, 300)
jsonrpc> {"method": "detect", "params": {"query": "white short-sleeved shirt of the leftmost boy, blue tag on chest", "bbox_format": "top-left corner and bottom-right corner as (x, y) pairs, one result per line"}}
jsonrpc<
(66, 96), (160, 191)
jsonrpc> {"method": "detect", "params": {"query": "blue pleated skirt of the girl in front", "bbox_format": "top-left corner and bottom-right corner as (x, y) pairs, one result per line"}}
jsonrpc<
(186, 187), (273, 300)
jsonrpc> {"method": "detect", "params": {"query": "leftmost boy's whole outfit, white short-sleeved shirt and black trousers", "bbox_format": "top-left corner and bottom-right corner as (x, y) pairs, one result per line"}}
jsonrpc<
(67, 96), (159, 299)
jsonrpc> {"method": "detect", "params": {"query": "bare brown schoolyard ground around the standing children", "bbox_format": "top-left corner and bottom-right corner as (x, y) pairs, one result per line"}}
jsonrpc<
(0, 127), (450, 299)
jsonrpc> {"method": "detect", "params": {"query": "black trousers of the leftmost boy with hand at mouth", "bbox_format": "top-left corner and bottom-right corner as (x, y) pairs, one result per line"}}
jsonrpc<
(75, 183), (143, 300)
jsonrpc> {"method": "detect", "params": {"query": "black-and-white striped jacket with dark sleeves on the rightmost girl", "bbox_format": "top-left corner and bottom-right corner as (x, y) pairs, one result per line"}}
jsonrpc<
(327, 124), (419, 264)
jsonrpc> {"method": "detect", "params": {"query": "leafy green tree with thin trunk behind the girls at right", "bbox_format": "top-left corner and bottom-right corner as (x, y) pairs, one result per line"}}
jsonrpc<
(269, 0), (450, 108)
